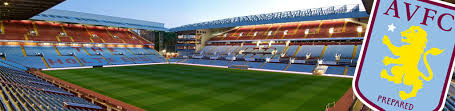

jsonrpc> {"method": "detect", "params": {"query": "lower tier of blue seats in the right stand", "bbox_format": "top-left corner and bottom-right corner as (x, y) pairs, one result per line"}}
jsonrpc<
(197, 44), (361, 65)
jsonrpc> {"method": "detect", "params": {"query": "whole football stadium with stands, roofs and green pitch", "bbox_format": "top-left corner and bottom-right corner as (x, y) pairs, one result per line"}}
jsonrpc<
(0, 0), (455, 111)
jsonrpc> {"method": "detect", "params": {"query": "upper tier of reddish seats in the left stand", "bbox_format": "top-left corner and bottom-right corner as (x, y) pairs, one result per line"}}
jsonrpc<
(0, 20), (151, 44)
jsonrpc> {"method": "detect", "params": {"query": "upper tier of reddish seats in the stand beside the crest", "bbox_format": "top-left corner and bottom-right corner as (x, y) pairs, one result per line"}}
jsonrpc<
(211, 20), (365, 41)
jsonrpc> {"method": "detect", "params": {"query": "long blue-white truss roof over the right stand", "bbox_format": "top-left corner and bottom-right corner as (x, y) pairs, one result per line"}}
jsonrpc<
(169, 4), (369, 32)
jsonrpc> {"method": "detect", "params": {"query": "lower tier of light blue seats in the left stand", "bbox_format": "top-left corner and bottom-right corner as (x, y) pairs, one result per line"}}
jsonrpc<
(0, 46), (165, 69)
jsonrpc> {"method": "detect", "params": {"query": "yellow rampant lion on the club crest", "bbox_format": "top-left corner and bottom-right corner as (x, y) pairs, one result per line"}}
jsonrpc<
(381, 26), (444, 100)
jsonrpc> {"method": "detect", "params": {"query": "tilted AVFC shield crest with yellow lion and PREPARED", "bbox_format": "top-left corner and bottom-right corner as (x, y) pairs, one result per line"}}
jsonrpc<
(353, 0), (455, 111)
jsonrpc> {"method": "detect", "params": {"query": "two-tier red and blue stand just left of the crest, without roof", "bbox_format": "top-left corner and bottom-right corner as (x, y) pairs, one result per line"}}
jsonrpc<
(174, 19), (365, 76)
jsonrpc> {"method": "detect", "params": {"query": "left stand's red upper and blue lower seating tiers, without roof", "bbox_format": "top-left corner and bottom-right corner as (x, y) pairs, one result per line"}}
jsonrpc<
(0, 20), (165, 69)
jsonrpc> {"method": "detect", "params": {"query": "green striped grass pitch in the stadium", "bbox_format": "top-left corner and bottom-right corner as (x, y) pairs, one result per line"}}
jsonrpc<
(44, 64), (352, 111)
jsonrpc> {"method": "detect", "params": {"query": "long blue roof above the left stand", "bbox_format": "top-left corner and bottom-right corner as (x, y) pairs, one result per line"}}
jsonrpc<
(31, 9), (167, 31)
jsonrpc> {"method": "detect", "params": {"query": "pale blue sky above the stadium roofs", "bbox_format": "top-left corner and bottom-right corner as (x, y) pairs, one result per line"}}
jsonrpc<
(53, 0), (362, 28)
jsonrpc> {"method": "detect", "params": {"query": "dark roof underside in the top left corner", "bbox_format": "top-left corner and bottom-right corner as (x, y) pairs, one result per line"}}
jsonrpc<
(0, 0), (65, 20)
